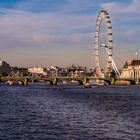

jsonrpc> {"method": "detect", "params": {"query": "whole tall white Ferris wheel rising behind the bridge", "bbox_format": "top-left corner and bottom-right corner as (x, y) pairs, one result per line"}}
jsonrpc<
(94, 10), (113, 77)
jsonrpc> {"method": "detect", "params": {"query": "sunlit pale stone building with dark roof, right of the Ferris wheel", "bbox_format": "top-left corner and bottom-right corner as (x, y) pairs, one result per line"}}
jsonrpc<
(120, 60), (140, 79)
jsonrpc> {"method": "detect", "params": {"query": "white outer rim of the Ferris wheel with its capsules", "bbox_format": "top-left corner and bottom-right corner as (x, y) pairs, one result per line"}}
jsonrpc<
(94, 10), (113, 76)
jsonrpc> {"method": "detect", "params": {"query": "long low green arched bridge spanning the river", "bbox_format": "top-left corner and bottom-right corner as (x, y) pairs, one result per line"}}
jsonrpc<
(0, 76), (140, 85)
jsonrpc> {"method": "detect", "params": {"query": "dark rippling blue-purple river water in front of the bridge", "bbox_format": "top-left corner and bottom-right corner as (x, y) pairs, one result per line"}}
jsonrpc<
(0, 85), (140, 140)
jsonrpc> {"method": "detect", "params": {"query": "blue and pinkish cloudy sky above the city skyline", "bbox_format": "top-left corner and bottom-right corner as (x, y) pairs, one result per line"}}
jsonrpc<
(0, 0), (140, 68)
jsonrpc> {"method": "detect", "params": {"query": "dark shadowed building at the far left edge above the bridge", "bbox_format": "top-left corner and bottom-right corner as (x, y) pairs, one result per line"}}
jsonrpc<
(0, 59), (11, 75)
